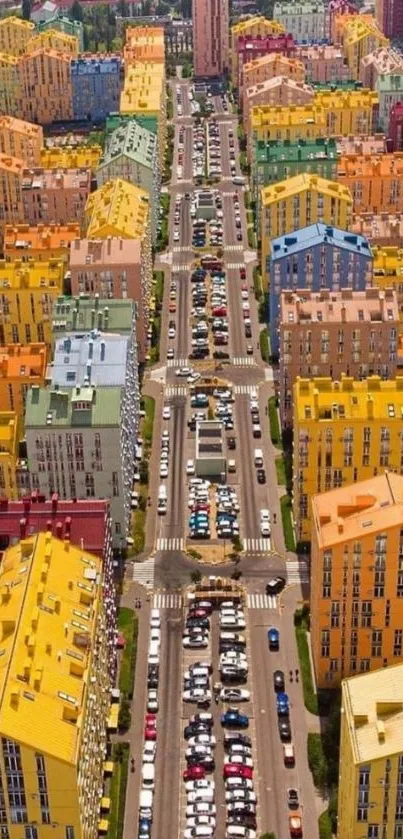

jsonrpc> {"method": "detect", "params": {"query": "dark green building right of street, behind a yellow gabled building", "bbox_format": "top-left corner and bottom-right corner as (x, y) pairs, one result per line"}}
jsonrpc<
(250, 137), (338, 226)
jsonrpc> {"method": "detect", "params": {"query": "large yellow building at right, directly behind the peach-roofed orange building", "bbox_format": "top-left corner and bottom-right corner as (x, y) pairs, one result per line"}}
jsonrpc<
(293, 378), (403, 541)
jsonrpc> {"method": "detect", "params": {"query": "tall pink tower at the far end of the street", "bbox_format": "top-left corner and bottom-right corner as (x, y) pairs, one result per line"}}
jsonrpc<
(192, 0), (229, 78)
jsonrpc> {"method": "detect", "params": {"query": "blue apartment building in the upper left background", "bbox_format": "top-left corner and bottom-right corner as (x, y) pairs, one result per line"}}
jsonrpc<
(71, 55), (121, 122)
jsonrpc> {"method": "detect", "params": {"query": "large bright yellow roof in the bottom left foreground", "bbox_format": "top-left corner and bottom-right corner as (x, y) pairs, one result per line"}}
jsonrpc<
(0, 533), (102, 764)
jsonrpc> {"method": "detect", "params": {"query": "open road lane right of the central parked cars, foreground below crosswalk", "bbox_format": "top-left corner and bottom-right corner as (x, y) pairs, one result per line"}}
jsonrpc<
(249, 609), (290, 836)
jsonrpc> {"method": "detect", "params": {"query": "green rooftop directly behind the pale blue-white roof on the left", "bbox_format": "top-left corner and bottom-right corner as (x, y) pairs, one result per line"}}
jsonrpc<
(52, 294), (136, 335)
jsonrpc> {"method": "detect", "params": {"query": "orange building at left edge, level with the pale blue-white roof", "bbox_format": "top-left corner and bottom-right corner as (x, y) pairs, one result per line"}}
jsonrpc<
(0, 344), (47, 424)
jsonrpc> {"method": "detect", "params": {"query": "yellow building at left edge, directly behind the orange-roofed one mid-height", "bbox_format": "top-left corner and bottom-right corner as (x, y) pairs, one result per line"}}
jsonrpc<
(0, 259), (65, 348)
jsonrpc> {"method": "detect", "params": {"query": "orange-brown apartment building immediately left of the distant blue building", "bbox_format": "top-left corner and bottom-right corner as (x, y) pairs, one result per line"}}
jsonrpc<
(18, 49), (74, 125)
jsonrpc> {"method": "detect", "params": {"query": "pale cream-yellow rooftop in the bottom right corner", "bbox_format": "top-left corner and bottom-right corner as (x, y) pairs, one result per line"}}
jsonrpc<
(342, 664), (403, 765)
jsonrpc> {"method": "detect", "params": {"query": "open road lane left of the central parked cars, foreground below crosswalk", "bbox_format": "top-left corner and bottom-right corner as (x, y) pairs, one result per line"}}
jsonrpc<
(152, 611), (183, 839)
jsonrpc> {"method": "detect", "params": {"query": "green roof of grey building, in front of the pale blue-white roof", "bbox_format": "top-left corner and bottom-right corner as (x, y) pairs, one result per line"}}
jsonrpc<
(25, 385), (122, 429)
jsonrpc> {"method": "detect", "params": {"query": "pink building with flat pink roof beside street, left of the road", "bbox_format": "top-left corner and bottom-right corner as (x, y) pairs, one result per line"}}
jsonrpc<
(70, 237), (150, 362)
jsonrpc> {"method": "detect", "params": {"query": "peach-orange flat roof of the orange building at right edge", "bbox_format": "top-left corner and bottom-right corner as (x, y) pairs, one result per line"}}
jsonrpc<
(312, 472), (403, 548)
